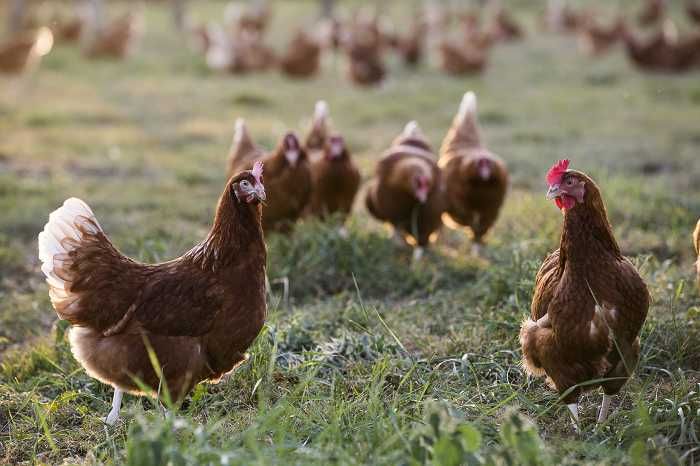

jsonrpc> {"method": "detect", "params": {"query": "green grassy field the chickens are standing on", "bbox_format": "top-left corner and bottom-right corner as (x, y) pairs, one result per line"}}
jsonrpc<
(0, 1), (700, 465)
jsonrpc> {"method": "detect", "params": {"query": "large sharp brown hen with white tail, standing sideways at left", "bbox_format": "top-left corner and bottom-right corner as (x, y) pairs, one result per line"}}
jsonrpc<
(39, 164), (267, 424)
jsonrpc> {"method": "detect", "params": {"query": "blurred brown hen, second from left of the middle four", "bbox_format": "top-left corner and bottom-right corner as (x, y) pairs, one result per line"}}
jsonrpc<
(306, 101), (360, 218)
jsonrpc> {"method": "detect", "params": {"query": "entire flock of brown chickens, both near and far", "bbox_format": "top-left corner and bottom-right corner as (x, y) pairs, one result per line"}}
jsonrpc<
(8, 0), (700, 436)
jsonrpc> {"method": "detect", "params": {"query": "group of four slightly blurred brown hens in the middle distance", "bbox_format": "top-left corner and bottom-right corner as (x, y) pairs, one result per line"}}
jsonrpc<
(228, 92), (508, 259)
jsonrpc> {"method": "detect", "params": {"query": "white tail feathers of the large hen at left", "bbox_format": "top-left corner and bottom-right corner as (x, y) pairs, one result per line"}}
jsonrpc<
(39, 197), (102, 294)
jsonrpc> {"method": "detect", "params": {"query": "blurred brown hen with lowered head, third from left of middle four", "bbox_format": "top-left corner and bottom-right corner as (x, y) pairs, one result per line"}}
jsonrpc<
(365, 121), (443, 260)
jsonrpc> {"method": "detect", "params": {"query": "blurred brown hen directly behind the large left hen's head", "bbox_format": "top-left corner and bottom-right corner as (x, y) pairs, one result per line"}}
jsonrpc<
(229, 125), (311, 232)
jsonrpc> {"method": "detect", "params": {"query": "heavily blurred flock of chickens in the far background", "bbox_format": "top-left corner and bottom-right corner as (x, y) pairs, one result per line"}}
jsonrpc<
(5, 0), (700, 78)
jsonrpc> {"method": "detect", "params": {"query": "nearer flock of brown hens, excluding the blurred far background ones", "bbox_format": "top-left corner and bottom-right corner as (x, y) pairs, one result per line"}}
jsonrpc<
(34, 84), (700, 430)
